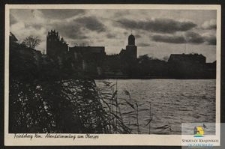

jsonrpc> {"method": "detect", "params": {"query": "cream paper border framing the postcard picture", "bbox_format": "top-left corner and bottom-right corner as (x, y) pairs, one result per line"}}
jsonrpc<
(4, 4), (221, 146)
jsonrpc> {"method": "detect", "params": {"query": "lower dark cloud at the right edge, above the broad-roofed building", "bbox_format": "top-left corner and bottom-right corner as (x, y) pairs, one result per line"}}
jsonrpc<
(151, 32), (216, 45)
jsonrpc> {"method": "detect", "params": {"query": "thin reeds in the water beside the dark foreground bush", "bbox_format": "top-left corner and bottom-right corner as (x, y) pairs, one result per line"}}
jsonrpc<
(98, 81), (153, 134)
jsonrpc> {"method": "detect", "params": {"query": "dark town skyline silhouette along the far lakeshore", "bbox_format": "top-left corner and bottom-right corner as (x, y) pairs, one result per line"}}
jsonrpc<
(10, 30), (216, 79)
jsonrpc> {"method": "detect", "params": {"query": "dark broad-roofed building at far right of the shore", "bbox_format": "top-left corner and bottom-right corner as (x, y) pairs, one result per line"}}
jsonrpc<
(167, 53), (216, 78)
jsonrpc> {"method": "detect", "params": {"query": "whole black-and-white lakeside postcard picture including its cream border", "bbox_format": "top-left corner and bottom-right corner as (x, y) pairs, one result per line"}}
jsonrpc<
(5, 5), (221, 144)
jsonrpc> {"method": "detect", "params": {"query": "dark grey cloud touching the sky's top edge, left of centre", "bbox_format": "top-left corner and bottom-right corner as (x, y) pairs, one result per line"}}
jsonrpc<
(40, 9), (85, 19)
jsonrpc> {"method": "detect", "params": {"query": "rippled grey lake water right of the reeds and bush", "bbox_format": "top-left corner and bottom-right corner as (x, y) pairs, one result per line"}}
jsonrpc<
(96, 79), (216, 134)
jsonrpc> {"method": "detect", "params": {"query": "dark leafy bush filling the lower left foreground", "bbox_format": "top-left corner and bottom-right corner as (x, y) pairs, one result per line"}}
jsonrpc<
(9, 79), (130, 133)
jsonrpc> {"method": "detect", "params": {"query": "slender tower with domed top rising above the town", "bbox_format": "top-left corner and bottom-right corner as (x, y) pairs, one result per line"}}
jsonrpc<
(126, 34), (137, 60)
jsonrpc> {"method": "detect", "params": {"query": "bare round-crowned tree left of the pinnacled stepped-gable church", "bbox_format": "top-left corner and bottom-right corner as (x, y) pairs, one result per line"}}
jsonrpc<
(22, 35), (41, 49)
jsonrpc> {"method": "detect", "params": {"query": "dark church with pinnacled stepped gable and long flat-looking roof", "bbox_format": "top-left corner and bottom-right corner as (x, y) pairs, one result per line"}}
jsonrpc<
(46, 30), (106, 75)
